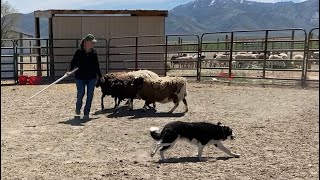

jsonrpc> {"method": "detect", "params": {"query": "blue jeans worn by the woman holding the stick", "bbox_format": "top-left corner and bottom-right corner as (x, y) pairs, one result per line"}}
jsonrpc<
(76, 78), (97, 115)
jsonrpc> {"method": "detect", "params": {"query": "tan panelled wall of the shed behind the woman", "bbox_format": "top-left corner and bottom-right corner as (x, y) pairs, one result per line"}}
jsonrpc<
(52, 16), (165, 76)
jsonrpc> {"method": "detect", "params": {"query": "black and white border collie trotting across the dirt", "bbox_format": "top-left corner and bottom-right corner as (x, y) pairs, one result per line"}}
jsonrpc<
(150, 121), (240, 160)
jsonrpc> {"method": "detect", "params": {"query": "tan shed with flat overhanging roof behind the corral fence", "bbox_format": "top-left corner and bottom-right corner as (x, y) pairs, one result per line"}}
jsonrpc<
(34, 10), (168, 76)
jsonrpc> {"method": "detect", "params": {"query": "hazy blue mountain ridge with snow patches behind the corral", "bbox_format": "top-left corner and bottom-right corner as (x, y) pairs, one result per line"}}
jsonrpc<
(10, 0), (319, 37)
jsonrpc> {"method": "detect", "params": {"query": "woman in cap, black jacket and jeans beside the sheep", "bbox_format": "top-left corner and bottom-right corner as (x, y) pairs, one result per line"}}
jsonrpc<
(67, 34), (104, 120)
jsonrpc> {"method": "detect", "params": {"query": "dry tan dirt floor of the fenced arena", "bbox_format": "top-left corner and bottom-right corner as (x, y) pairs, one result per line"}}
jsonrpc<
(1, 83), (319, 180)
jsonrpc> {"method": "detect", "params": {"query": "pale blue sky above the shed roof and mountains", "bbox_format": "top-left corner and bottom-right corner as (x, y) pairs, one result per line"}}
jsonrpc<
(8, 0), (304, 13)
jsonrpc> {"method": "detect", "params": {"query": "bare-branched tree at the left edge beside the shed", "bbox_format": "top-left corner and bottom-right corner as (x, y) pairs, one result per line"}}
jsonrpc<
(1, 1), (19, 47)
